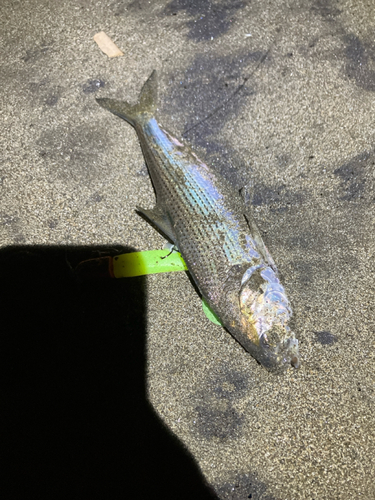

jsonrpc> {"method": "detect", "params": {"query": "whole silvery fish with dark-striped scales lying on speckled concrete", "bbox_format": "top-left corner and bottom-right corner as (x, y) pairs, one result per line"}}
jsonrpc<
(96, 70), (300, 372)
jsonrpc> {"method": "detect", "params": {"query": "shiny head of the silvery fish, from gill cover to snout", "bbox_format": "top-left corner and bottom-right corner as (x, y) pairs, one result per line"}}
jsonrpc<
(239, 264), (300, 371)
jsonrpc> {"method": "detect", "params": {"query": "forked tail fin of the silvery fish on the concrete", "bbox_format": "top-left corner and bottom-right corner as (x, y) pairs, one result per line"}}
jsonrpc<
(96, 70), (158, 127)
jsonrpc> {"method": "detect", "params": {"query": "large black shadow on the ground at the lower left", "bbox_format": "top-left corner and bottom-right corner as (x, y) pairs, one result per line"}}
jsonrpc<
(0, 246), (217, 500)
